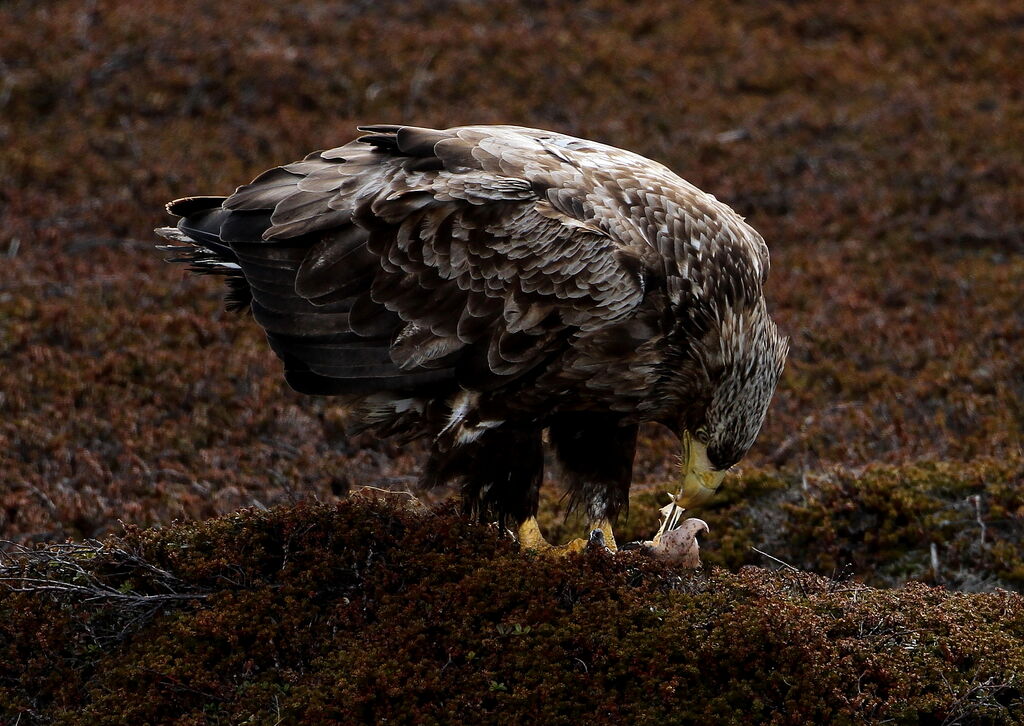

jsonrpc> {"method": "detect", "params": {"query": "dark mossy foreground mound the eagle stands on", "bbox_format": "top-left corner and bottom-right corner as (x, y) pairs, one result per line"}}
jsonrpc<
(0, 498), (1024, 725)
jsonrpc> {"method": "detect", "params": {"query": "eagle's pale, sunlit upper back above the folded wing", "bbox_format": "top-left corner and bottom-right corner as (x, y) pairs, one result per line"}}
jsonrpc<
(413, 126), (769, 283)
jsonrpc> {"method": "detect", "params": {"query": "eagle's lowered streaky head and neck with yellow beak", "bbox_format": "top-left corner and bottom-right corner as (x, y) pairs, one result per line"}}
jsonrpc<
(676, 260), (790, 508)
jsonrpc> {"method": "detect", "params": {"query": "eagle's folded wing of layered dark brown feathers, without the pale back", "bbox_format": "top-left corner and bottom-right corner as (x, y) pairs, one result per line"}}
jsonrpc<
(214, 127), (643, 387)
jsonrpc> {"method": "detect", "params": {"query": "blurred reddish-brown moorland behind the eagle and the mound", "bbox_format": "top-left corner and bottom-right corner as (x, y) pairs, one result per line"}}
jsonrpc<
(0, 0), (1024, 580)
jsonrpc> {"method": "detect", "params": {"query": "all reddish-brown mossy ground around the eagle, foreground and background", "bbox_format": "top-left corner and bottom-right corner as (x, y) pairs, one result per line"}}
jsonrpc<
(0, 0), (1024, 724)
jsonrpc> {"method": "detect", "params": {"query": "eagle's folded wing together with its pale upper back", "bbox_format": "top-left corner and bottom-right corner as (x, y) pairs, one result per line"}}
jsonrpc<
(188, 125), (767, 397)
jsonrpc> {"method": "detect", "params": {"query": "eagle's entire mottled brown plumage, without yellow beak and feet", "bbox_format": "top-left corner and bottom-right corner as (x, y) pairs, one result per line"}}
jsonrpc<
(160, 121), (785, 536)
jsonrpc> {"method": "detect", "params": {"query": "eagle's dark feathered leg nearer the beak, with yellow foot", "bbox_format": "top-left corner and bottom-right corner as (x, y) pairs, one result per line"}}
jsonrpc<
(549, 412), (637, 550)
